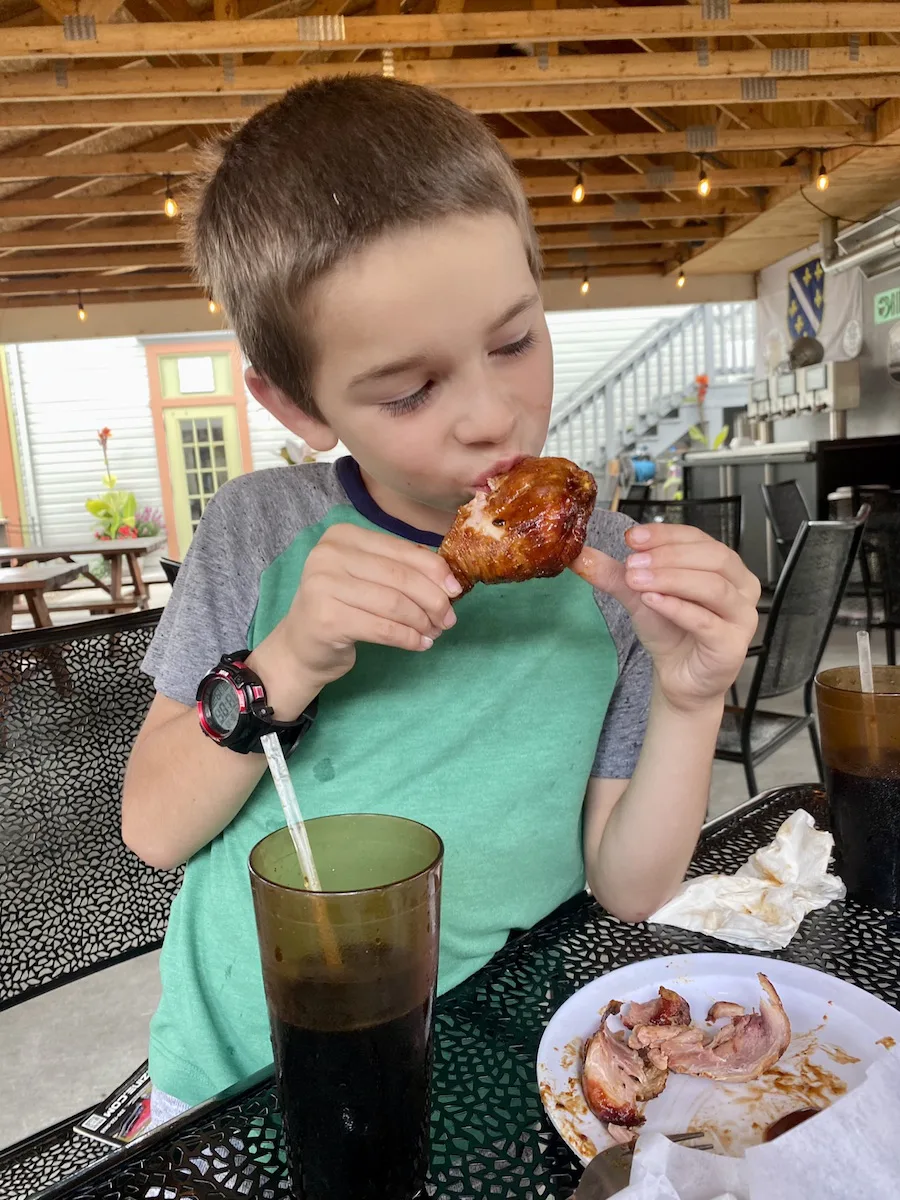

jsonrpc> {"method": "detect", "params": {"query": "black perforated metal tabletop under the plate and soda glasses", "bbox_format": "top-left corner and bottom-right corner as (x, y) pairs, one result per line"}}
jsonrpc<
(8, 785), (900, 1200)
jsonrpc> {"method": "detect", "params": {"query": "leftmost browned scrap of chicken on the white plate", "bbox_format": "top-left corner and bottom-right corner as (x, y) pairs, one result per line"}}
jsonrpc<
(582, 1000), (666, 1140)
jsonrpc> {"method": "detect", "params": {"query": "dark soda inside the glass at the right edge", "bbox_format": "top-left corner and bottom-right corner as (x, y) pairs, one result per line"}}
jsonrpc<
(826, 750), (900, 911)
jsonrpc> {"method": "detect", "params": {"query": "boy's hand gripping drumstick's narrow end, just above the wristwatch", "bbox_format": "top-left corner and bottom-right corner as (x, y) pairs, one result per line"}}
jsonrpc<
(253, 524), (461, 712)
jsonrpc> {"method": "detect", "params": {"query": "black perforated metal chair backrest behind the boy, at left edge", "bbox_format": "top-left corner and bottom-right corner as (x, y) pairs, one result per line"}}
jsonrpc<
(0, 610), (180, 1009)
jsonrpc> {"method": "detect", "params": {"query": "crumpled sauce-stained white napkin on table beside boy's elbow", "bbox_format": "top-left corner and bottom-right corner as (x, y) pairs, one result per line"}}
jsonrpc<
(649, 809), (846, 950)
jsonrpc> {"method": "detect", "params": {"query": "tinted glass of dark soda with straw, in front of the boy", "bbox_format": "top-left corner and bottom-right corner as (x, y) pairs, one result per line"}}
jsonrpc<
(250, 814), (444, 1200)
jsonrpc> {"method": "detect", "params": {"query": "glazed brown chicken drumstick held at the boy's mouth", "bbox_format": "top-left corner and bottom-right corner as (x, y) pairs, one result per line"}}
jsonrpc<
(438, 458), (596, 594)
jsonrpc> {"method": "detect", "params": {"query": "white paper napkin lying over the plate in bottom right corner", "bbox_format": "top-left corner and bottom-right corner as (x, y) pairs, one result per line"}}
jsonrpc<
(607, 1050), (900, 1200)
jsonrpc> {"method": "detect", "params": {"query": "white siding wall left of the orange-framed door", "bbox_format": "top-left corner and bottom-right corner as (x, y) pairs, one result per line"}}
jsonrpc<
(8, 337), (162, 545)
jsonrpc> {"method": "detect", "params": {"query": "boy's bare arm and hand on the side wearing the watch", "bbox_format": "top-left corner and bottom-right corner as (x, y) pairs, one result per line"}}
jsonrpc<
(122, 524), (460, 869)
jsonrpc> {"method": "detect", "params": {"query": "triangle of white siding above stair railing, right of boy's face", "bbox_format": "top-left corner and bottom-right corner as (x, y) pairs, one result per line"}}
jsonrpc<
(547, 305), (689, 407)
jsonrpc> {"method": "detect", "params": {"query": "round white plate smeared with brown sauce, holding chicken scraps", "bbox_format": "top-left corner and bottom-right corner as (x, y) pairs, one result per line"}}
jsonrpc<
(538, 954), (900, 1163)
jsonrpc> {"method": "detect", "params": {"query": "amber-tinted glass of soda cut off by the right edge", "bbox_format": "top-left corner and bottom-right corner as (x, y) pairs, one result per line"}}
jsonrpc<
(816, 666), (900, 912)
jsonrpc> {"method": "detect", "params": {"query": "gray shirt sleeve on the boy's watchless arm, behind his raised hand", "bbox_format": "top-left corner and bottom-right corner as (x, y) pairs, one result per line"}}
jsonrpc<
(587, 509), (653, 779)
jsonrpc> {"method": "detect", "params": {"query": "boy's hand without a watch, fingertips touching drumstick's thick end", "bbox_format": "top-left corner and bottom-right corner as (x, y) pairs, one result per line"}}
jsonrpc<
(572, 523), (760, 712)
